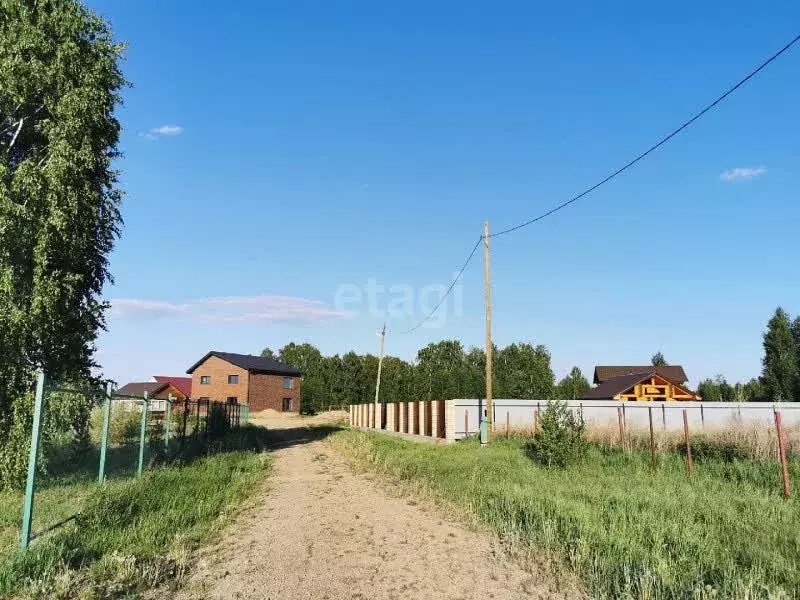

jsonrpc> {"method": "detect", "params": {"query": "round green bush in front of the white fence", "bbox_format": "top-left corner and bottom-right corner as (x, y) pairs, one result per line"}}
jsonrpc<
(525, 400), (588, 469)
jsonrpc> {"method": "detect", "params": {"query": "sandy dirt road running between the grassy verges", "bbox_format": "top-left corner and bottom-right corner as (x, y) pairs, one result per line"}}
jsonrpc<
(178, 420), (564, 600)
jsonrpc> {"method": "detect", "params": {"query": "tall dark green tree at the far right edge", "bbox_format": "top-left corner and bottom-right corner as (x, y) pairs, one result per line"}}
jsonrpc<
(761, 307), (798, 402)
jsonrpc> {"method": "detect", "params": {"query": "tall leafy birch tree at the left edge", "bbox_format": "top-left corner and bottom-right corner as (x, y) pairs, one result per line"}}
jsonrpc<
(0, 0), (125, 487)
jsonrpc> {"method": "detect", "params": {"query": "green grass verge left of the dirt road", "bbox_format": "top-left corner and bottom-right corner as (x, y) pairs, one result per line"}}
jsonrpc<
(0, 427), (269, 600)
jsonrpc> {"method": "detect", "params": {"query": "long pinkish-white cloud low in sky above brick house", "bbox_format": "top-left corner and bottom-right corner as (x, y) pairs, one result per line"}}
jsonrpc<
(111, 296), (351, 323)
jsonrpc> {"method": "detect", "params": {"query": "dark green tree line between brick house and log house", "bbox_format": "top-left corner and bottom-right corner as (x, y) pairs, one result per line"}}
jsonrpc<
(261, 340), (591, 412)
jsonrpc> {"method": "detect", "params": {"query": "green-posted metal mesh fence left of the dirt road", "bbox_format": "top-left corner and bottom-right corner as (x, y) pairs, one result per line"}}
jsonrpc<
(20, 372), (249, 551)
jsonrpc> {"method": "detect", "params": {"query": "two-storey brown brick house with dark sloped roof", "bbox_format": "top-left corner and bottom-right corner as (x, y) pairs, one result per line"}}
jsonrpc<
(186, 350), (303, 412)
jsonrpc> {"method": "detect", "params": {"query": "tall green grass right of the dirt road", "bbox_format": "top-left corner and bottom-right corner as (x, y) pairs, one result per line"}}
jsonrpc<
(332, 430), (800, 599)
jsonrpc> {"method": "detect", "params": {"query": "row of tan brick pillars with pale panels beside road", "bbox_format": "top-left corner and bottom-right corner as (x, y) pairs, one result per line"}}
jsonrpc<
(349, 400), (456, 442)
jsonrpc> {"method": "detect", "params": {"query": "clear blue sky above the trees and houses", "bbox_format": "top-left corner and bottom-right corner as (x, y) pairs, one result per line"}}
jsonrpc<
(90, 0), (800, 390)
